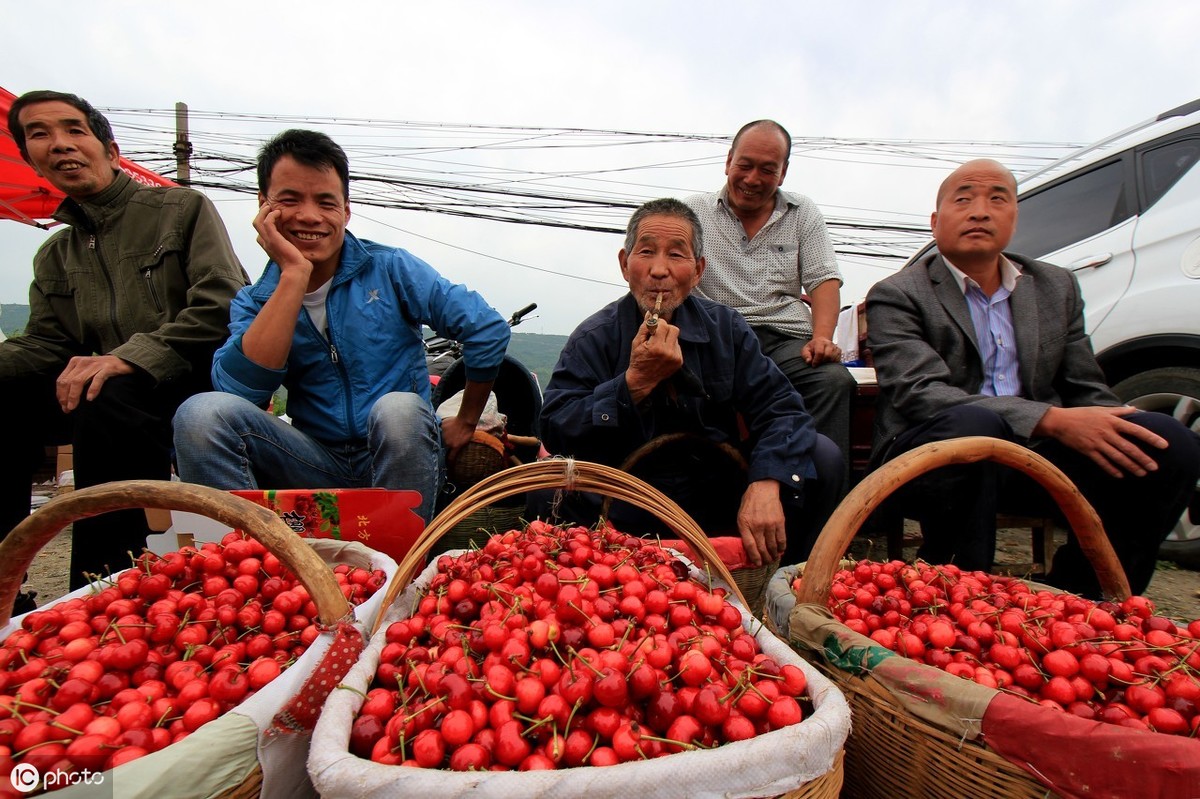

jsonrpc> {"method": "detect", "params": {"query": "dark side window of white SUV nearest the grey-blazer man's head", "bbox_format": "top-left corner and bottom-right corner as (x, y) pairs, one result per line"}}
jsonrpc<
(1007, 160), (1133, 258)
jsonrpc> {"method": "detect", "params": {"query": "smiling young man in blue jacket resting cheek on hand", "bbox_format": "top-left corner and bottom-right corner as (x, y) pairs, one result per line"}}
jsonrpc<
(175, 130), (509, 522)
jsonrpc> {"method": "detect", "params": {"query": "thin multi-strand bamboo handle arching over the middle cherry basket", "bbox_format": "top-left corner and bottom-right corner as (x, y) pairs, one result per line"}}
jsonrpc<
(369, 458), (746, 632)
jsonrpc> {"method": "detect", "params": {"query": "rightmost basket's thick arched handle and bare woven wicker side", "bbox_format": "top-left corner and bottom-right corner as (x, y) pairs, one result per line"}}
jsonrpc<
(790, 437), (1129, 799)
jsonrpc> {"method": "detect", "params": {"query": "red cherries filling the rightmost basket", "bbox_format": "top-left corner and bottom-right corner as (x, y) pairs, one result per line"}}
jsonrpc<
(793, 560), (1200, 737)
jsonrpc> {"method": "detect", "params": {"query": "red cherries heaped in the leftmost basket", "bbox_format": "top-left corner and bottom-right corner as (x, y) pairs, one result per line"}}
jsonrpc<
(0, 531), (386, 795)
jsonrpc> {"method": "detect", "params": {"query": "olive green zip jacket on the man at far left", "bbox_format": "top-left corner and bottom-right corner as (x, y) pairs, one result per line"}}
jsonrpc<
(0, 172), (250, 383)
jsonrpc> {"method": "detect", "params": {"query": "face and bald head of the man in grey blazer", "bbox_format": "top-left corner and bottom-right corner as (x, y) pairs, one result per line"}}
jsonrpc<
(929, 161), (1016, 265)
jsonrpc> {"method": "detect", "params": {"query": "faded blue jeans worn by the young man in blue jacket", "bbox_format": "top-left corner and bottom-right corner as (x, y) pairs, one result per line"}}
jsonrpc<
(175, 391), (445, 523)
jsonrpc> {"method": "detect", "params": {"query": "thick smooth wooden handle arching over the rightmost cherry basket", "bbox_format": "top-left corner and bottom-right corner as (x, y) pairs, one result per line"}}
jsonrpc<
(797, 435), (1129, 606)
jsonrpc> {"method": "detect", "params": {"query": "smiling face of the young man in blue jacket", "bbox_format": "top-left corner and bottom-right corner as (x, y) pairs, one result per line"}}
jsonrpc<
(258, 156), (350, 275)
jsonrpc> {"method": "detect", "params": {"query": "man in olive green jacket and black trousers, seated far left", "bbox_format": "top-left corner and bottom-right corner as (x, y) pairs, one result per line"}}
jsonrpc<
(0, 91), (248, 595)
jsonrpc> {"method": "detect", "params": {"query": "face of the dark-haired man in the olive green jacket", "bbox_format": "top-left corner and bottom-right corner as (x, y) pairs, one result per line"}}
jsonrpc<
(18, 100), (120, 199)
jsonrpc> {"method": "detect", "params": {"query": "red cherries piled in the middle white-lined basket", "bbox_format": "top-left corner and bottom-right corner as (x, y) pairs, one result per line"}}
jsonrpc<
(350, 522), (811, 770)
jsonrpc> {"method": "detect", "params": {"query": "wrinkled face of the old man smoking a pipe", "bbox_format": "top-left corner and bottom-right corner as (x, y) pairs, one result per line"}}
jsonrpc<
(617, 215), (704, 320)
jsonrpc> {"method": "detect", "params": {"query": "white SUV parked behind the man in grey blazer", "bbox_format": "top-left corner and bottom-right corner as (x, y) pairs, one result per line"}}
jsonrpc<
(907, 100), (1200, 569)
